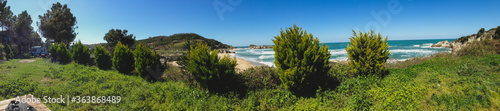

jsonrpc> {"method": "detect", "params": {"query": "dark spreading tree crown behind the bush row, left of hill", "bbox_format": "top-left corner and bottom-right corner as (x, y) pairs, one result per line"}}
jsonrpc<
(104, 29), (135, 47)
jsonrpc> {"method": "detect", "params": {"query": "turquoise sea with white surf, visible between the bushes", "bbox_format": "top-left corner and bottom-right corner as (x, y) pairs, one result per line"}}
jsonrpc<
(231, 39), (455, 66)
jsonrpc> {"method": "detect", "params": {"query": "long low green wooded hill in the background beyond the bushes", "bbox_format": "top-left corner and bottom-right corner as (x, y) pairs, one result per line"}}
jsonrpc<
(134, 33), (231, 50)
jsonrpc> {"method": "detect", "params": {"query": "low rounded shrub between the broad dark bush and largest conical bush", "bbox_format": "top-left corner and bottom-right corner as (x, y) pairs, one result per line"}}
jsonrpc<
(240, 66), (281, 91)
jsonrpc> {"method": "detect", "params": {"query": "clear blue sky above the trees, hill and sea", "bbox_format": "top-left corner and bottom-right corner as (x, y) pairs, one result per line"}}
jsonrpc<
(8, 0), (500, 46)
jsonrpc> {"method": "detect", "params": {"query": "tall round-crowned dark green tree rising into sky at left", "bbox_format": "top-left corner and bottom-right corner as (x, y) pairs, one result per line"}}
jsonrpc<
(38, 2), (77, 44)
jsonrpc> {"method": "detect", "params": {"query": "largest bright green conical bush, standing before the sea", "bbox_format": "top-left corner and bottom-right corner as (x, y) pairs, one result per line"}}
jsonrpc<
(273, 24), (330, 95)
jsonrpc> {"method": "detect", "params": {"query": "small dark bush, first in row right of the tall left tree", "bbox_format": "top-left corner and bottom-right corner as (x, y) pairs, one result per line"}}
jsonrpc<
(72, 41), (92, 65)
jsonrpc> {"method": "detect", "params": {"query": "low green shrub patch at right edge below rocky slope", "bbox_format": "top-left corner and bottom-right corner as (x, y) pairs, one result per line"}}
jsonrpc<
(457, 39), (500, 56)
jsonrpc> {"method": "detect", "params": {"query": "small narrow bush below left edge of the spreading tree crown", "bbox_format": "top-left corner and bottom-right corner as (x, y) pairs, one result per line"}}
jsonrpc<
(94, 45), (113, 70)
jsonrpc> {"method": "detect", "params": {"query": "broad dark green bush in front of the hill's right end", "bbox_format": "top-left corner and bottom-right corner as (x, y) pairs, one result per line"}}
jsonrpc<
(186, 43), (236, 93)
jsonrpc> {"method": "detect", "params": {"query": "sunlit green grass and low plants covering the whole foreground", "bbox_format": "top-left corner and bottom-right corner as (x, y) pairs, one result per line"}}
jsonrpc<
(0, 54), (500, 110)
